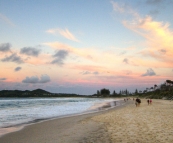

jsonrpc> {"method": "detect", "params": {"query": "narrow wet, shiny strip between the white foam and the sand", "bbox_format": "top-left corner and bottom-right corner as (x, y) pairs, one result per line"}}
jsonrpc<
(0, 99), (124, 138)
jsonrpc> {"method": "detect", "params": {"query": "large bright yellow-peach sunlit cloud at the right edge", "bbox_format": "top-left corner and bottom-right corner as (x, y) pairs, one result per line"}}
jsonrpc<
(124, 16), (173, 63)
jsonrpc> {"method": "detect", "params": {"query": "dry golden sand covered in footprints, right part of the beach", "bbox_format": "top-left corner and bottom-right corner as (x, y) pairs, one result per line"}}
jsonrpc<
(92, 100), (173, 143)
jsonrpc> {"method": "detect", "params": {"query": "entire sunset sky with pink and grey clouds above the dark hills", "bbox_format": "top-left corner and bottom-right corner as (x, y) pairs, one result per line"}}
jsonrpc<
(0, 0), (173, 95)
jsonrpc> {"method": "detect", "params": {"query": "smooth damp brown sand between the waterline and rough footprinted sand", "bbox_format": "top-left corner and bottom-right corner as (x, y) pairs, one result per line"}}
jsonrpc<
(0, 101), (130, 143)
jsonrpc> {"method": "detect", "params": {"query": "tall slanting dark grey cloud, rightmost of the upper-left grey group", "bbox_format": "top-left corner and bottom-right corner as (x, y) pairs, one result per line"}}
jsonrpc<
(51, 50), (68, 66)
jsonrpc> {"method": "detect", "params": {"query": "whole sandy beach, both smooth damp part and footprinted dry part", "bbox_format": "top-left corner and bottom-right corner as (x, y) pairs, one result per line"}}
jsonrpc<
(0, 99), (173, 143)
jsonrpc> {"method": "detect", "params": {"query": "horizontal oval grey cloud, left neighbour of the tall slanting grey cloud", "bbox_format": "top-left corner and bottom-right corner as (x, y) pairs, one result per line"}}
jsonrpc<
(20, 47), (40, 57)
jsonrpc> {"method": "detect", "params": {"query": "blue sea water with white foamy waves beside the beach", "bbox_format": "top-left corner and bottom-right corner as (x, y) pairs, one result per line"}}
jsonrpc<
(0, 98), (121, 135)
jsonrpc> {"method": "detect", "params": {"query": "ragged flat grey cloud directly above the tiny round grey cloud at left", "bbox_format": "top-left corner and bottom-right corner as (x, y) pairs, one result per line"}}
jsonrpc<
(1, 53), (24, 64)
